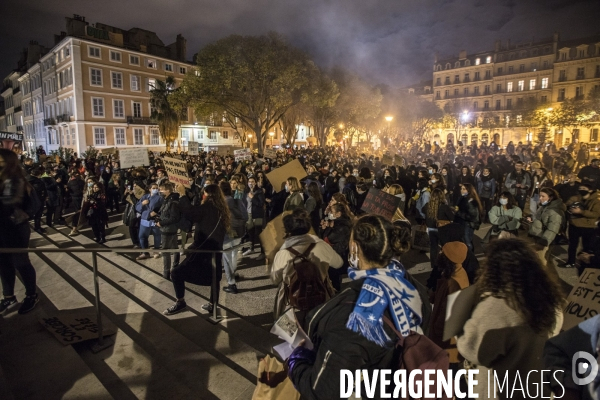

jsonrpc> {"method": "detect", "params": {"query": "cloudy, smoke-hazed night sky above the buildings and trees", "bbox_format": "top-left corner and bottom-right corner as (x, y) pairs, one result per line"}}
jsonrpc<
(0, 0), (600, 86)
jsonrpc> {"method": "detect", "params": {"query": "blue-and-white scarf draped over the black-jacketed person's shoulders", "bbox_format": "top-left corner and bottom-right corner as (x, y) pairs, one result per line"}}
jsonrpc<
(346, 260), (422, 347)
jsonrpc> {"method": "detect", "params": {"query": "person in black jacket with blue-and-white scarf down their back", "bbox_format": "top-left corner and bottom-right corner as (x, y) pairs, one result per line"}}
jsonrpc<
(286, 215), (426, 400)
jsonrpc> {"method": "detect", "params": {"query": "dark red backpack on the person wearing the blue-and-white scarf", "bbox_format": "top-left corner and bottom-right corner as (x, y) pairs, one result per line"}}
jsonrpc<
(383, 316), (452, 400)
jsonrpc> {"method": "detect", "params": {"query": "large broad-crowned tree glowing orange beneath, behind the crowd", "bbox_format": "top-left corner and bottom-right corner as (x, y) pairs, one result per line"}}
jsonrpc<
(182, 33), (316, 153)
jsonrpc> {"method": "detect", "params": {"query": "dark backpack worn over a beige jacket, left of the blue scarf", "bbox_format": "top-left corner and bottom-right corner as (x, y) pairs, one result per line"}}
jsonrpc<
(287, 243), (333, 311)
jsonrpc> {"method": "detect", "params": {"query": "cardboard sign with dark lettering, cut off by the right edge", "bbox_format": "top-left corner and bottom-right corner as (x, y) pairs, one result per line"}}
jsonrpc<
(562, 268), (600, 331)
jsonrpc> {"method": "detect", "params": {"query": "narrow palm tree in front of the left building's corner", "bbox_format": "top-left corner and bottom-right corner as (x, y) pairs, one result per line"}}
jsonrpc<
(150, 76), (180, 151)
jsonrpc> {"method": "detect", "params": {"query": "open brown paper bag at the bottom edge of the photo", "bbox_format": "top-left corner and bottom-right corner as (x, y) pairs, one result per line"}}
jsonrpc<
(252, 354), (300, 400)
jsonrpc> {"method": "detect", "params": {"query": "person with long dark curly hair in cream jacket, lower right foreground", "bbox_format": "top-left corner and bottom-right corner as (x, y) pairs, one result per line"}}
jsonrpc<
(458, 239), (564, 399)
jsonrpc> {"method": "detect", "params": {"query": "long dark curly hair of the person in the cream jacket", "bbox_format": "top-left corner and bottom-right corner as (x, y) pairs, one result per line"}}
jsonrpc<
(477, 239), (564, 333)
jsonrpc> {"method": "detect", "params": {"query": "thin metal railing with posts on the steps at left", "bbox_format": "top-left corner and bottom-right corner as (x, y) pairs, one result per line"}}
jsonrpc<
(0, 244), (244, 353)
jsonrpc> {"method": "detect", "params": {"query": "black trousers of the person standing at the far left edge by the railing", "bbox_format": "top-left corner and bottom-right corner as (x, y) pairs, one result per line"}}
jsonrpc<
(0, 222), (36, 297)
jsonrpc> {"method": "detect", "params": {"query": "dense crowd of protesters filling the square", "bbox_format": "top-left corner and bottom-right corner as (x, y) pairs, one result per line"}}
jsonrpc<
(0, 137), (600, 399)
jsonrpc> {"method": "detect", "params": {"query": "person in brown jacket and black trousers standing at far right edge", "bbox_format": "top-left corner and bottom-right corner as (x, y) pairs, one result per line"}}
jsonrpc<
(565, 183), (600, 268)
